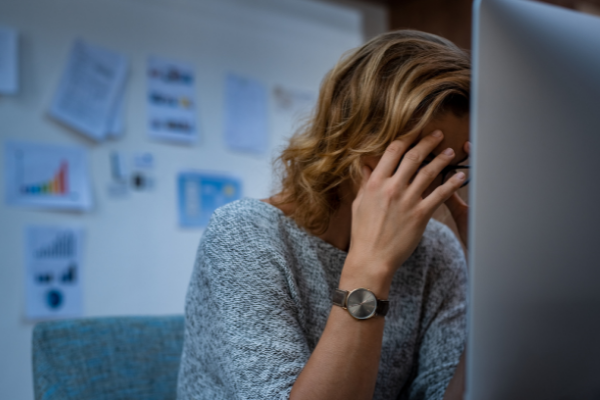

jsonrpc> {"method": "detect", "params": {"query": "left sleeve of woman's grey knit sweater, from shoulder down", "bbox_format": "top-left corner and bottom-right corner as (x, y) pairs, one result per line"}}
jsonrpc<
(179, 203), (310, 400)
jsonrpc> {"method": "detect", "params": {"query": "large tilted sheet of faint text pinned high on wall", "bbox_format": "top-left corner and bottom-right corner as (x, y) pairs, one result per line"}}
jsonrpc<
(49, 40), (128, 140)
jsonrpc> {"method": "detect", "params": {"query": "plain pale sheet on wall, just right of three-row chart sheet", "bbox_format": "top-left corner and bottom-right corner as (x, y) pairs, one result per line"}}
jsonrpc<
(224, 73), (269, 154)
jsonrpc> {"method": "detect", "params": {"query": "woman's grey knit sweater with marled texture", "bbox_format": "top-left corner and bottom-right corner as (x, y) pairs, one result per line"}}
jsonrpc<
(177, 199), (466, 400)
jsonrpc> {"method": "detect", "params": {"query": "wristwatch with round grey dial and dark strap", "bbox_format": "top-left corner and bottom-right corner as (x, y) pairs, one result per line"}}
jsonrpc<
(333, 288), (390, 319)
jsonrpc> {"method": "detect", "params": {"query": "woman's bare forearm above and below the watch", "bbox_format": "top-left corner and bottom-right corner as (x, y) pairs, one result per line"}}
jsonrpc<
(290, 259), (392, 400)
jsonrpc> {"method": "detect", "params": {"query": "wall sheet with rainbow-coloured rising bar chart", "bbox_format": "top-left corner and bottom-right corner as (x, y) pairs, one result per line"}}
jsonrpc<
(4, 141), (92, 210)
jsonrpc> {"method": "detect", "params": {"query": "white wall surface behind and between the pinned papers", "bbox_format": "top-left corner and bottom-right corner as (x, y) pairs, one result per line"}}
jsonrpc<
(0, 0), (362, 400)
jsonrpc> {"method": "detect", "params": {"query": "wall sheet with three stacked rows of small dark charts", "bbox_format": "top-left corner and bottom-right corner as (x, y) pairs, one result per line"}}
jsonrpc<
(147, 57), (198, 143)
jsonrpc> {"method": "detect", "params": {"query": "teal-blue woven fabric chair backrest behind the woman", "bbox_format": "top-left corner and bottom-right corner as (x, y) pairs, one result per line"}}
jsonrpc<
(33, 316), (184, 400)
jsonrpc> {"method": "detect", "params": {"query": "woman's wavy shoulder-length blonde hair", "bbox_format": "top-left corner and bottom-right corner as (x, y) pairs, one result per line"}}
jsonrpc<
(273, 30), (471, 234)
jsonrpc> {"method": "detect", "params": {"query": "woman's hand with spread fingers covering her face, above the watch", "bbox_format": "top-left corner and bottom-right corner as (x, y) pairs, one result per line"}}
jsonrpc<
(348, 130), (465, 274)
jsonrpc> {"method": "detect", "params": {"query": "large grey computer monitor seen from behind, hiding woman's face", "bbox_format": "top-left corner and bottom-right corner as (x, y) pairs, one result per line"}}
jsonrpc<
(466, 0), (600, 400)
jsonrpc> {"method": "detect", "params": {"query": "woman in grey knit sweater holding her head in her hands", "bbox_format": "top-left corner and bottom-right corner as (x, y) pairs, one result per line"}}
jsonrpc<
(178, 31), (470, 400)
